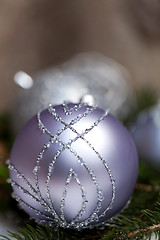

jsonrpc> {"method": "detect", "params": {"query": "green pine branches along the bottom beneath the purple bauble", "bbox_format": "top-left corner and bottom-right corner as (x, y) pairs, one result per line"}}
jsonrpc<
(0, 203), (160, 240)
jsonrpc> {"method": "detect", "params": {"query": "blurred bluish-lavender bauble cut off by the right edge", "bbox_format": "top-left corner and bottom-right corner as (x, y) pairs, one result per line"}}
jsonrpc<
(131, 104), (160, 165)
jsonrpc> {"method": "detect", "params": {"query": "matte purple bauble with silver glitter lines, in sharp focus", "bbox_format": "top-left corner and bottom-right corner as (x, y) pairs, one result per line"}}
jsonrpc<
(9, 101), (138, 229)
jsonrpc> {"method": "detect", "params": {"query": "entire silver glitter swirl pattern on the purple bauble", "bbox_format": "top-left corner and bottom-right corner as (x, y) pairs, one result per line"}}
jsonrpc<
(9, 103), (115, 229)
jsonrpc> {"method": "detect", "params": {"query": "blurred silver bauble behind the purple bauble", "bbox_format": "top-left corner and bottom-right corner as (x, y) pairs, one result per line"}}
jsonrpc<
(12, 53), (133, 132)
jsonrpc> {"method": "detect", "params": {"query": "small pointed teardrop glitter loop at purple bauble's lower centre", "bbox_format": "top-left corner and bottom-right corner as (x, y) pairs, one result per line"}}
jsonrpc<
(60, 168), (88, 226)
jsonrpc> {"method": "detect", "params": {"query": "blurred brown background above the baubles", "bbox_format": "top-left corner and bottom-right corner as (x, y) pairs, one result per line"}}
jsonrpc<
(0, 0), (160, 111)
